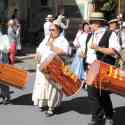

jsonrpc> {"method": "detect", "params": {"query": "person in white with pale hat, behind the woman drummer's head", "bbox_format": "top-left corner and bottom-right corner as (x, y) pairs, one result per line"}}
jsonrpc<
(44, 14), (54, 37)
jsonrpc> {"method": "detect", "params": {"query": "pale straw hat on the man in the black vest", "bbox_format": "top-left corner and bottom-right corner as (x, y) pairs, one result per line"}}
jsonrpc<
(89, 12), (106, 22)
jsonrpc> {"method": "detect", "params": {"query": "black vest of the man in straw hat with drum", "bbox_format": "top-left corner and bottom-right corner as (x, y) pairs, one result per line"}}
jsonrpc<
(96, 31), (115, 65)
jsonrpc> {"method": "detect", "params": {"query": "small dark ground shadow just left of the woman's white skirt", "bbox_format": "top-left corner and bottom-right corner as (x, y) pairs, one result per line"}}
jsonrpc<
(11, 93), (33, 105)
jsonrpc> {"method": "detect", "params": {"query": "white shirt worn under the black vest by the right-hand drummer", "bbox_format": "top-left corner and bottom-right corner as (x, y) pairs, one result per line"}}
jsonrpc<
(86, 28), (121, 64)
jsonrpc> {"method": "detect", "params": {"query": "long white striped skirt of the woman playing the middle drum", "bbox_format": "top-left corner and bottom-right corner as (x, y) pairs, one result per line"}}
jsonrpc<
(32, 64), (62, 108)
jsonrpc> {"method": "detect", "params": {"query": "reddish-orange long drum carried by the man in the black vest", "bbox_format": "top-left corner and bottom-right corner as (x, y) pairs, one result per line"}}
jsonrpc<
(87, 60), (125, 95)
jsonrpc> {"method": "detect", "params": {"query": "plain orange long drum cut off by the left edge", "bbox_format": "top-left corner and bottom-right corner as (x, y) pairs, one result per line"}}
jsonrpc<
(0, 64), (28, 89)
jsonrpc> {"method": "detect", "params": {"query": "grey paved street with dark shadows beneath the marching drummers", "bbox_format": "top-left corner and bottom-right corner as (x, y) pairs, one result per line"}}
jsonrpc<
(0, 55), (125, 125)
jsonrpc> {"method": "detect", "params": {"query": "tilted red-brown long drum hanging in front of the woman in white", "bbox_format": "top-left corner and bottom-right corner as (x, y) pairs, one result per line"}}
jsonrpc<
(41, 55), (82, 96)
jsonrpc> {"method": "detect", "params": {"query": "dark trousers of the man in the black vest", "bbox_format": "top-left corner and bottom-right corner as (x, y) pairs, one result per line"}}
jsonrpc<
(88, 86), (113, 119)
